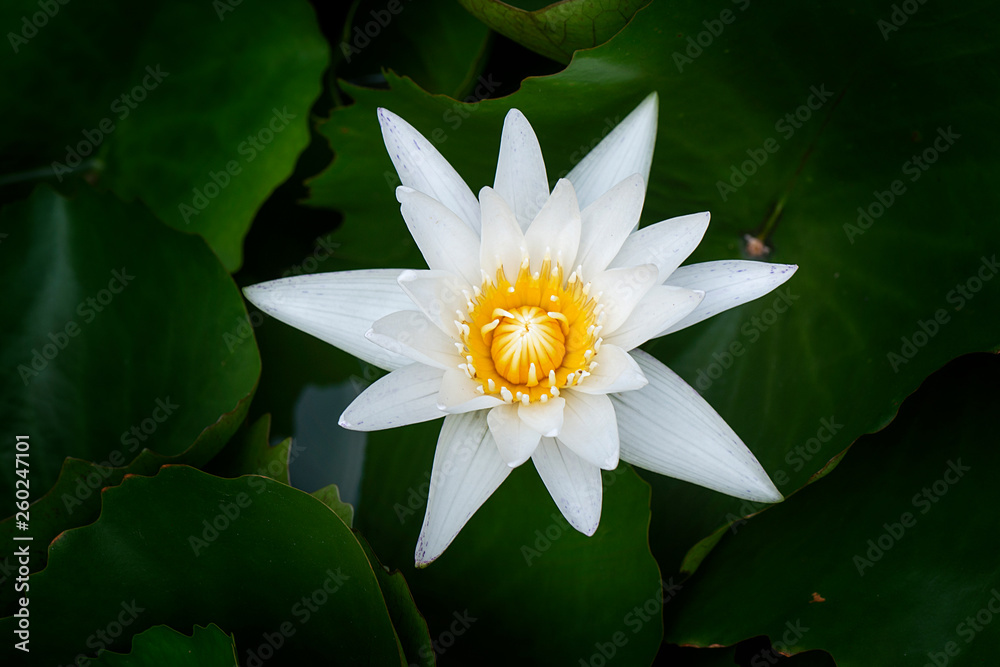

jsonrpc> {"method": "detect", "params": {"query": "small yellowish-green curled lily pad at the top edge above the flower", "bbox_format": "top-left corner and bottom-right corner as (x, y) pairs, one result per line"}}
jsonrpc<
(459, 0), (649, 63)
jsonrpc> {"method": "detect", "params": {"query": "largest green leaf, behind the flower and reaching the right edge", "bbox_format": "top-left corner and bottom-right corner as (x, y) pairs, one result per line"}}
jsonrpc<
(312, 1), (1000, 571)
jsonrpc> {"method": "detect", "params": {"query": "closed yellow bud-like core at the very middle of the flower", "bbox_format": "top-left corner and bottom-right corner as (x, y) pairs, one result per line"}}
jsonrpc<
(490, 306), (566, 387)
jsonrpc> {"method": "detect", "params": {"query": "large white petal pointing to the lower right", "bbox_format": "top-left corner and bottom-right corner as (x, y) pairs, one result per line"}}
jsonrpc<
(612, 350), (782, 503)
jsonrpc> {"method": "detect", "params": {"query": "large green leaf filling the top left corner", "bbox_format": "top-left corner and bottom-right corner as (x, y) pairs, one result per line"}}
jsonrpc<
(0, 0), (329, 270)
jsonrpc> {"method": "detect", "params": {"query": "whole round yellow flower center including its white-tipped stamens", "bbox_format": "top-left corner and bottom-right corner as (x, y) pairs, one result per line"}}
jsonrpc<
(455, 258), (604, 404)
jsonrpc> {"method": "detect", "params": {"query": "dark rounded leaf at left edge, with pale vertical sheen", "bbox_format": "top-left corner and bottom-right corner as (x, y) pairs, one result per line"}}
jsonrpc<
(0, 188), (260, 580)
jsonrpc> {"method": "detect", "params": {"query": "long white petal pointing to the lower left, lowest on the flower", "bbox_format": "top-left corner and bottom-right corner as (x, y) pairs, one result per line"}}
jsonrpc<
(414, 412), (511, 567)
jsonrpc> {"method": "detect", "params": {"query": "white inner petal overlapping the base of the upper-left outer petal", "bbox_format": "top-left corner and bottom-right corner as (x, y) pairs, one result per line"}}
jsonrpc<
(396, 185), (481, 285)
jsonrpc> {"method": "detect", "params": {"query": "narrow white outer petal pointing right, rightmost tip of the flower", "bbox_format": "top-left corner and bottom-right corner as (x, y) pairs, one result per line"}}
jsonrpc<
(660, 260), (799, 335)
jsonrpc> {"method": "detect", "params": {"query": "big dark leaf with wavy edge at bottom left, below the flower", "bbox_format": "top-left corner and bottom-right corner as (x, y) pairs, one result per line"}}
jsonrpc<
(0, 466), (402, 665)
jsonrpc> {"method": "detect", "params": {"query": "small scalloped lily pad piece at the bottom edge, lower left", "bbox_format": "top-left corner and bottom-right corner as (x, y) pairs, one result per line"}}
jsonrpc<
(94, 623), (239, 667)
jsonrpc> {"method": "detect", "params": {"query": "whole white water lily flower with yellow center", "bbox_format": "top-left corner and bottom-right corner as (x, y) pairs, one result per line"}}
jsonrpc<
(244, 93), (796, 565)
